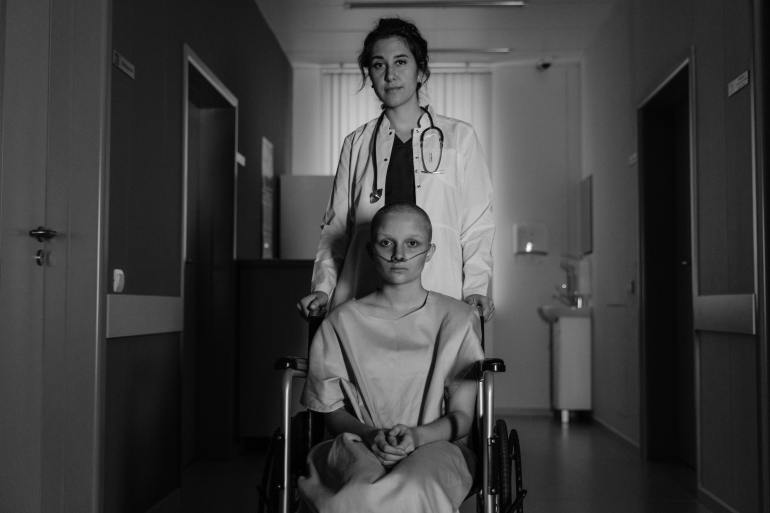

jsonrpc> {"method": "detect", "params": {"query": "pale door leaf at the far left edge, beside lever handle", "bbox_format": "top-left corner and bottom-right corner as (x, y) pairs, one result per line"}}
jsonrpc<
(0, 0), (48, 504)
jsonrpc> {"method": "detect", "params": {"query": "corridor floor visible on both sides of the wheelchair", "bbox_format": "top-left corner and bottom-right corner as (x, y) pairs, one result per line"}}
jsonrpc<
(182, 416), (709, 513)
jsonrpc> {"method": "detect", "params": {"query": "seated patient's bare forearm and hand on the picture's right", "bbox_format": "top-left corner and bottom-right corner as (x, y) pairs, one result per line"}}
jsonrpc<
(388, 380), (476, 453)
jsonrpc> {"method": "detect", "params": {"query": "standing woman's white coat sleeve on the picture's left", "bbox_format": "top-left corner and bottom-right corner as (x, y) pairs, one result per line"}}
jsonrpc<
(311, 134), (353, 297)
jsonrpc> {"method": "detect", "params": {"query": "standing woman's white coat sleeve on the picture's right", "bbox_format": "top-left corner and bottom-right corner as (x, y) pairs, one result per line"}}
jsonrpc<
(460, 128), (495, 297)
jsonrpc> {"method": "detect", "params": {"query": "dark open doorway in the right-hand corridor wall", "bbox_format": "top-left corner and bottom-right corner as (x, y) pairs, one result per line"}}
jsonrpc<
(638, 61), (697, 470)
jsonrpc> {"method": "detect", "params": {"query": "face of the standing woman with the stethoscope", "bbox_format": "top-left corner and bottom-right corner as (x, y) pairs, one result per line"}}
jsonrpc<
(369, 36), (421, 109)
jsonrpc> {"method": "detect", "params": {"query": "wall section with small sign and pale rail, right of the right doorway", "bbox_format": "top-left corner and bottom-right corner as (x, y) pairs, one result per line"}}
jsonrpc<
(693, 0), (768, 513)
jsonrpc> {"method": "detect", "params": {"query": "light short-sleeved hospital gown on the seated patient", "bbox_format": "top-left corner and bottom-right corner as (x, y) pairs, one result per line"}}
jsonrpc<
(299, 292), (483, 513)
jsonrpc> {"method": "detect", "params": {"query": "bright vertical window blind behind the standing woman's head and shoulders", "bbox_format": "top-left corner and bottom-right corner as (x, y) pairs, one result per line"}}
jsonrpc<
(321, 69), (491, 174)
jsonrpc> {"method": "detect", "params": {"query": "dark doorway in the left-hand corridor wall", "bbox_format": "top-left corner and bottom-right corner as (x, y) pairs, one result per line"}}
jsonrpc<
(181, 47), (238, 466)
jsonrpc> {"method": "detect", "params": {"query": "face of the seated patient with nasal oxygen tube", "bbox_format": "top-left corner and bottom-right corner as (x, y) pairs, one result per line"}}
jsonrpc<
(372, 212), (434, 284)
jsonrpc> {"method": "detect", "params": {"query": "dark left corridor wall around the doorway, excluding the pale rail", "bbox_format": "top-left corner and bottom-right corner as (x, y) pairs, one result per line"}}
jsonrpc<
(104, 0), (291, 513)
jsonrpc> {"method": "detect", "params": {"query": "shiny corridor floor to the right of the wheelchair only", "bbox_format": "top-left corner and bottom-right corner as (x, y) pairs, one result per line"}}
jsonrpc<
(498, 417), (709, 513)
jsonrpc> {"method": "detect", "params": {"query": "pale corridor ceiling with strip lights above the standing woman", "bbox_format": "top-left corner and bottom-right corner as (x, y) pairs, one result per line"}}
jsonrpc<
(255, 0), (620, 65)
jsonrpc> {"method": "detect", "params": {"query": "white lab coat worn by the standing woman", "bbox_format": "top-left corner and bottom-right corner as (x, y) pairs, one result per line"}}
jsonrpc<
(312, 110), (495, 307)
